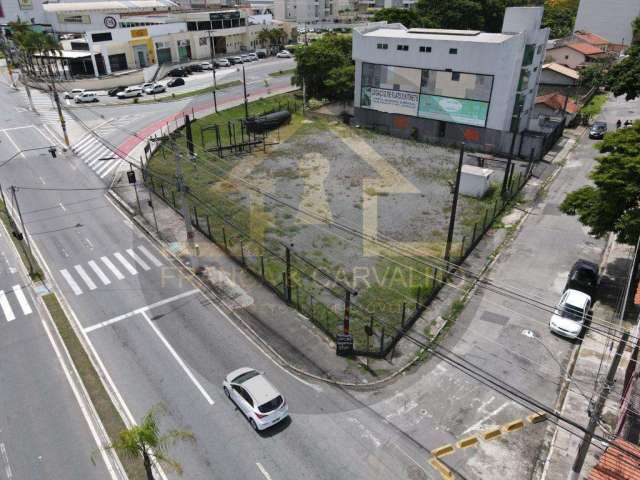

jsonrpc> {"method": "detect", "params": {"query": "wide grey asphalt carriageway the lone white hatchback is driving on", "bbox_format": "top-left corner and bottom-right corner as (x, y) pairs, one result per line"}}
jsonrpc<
(0, 79), (444, 480)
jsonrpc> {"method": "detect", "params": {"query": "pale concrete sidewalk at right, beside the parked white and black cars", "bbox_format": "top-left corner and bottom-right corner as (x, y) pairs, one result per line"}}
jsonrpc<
(541, 234), (633, 480)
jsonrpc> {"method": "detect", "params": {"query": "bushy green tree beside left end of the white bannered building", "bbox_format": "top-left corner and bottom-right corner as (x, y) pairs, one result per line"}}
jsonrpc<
(293, 34), (353, 101)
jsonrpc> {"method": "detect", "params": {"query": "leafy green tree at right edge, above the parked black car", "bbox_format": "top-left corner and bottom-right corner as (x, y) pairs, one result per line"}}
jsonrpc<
(560, 122), (640, 244)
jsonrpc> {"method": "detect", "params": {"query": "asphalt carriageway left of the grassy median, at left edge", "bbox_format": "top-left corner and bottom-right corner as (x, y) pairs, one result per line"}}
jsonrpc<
(0, 186), (109, 480)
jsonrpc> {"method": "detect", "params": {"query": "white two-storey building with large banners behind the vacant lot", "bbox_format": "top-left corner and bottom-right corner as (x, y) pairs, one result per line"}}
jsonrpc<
(353, 7), (549, 156)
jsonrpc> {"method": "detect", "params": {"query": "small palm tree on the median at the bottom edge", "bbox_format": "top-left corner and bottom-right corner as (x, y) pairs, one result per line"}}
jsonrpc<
(97, 405), (195, 480)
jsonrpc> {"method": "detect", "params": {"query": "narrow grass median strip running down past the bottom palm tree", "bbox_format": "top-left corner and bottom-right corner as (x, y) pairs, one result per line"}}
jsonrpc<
(42, 293), (146, 480)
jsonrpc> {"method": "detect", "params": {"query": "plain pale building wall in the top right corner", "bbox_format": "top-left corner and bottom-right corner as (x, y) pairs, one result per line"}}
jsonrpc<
(574, 0), (640, 45)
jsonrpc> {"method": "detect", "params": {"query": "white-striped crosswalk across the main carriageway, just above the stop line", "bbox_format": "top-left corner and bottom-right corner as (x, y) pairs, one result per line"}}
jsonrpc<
(59, 245), (162, 294)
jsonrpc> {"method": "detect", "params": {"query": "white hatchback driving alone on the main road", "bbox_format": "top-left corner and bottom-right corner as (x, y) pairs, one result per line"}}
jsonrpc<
(222, 367), (289, 430)
